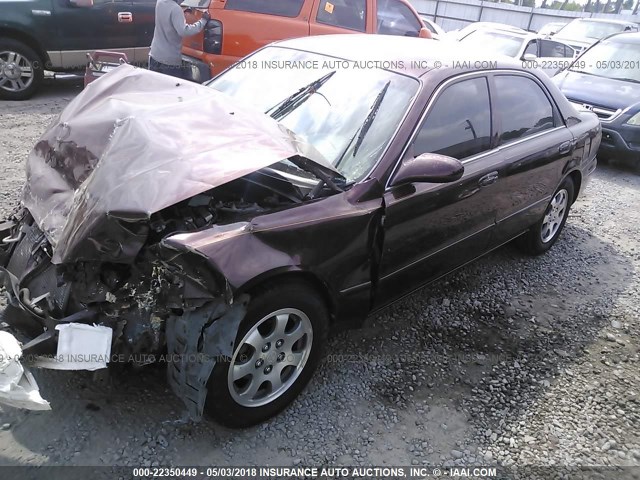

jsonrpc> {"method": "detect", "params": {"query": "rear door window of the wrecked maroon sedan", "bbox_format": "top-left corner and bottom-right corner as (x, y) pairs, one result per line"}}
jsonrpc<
(493, 75), (555, 144)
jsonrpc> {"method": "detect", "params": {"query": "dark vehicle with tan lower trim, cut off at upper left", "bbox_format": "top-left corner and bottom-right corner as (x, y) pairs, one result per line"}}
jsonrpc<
(0, 0), (156, 100)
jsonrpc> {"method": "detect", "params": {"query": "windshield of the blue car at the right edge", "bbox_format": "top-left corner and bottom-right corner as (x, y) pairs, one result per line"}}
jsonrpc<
(570, 41), (640, 82)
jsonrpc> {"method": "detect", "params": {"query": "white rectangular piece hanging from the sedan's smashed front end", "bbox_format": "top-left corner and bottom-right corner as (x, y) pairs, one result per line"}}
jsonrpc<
(36, 323), (113, 371)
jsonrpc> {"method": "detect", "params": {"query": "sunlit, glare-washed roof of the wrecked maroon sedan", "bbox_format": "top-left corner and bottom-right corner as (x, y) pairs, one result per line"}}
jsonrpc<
(273, 34), (522, 78)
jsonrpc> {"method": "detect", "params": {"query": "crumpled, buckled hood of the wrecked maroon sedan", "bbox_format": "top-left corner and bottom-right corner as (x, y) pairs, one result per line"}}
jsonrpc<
(23, 65), (331, 264)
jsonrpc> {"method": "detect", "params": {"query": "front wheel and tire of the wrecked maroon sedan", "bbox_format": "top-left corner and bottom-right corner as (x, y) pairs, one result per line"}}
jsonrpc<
(205, 282), (329, 428)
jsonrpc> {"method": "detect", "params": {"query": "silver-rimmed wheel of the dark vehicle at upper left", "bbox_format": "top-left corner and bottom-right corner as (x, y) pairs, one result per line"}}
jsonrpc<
(0, 38), (44, 100)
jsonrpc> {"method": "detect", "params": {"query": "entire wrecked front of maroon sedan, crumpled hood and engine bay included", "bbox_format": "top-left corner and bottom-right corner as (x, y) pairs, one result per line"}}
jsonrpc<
(0, 65), (344, 418)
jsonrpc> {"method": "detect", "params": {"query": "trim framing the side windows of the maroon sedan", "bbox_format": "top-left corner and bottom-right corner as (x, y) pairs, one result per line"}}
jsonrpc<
(384, 69), (567, 193)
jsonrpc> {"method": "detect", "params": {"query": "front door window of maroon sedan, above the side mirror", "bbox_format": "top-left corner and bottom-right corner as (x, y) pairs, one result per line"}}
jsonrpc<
(413, 77), (491, 160)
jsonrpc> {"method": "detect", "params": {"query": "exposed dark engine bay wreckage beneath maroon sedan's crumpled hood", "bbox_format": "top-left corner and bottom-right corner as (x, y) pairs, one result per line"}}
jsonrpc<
(0, 169), (312, 418)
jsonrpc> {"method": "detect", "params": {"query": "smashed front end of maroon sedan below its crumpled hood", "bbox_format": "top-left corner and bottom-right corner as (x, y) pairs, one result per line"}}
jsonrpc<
(0, 210), (248, 418)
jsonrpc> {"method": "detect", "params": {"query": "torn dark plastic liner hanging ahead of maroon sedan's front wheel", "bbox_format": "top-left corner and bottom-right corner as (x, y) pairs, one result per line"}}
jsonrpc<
(167, 295), (249, 420)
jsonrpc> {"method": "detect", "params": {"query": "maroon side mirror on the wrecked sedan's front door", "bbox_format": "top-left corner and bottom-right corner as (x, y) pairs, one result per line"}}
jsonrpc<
(391, 153), (464, 187)
